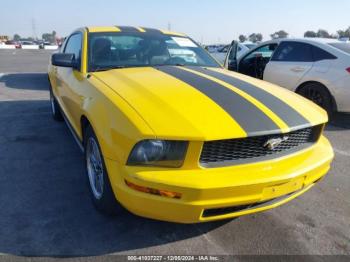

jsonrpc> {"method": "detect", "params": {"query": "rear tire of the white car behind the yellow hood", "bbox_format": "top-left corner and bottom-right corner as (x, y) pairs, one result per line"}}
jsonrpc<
(297, 83), (334, 118)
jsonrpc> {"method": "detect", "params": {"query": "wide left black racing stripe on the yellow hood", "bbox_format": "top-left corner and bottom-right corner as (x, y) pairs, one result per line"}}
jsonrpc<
(157, 66), (281, 136)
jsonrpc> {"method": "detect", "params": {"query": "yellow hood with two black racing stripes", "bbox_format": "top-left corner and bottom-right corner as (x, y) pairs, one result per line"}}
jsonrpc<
(92, 66), (327, 140)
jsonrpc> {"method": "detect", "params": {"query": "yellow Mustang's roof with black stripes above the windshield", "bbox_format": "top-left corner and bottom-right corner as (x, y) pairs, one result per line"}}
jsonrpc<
(86, 26), (186, 36)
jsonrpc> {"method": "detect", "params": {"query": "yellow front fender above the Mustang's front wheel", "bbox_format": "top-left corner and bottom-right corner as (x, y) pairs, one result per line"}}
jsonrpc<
(82, 77), (155, 163)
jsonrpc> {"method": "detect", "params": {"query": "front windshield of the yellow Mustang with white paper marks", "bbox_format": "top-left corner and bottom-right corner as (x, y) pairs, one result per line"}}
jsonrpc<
(88, 32), (219, 71)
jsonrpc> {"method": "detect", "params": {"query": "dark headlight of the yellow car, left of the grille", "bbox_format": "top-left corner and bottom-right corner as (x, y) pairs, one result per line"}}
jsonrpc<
(127, 140), (188, 167)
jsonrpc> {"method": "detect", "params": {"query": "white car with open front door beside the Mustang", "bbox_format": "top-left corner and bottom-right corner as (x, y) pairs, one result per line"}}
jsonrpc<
(224, 38), (350, 115)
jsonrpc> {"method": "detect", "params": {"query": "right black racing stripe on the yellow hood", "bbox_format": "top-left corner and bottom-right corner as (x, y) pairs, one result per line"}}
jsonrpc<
(188, 66), (311, 130)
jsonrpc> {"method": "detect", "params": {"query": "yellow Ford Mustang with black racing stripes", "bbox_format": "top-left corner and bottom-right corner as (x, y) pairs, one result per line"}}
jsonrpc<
(49, 26), (333, 223)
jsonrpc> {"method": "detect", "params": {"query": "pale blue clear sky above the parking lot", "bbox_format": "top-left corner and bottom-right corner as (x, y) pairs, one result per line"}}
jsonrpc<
(0, 0), (350, 44)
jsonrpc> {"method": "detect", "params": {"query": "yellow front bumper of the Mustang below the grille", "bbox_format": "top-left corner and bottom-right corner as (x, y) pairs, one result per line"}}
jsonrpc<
(106, 137), (334, 223)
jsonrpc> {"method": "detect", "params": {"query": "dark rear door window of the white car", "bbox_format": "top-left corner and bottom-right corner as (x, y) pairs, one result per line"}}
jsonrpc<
(271, 42), (313, 62)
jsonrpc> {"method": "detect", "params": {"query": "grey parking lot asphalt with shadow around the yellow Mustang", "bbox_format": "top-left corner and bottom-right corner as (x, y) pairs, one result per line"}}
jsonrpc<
(0, 50), (350, 257)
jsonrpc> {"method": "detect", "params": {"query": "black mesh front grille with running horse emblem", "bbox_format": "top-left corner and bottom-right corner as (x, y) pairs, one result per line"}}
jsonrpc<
(200, 126), (322, 167)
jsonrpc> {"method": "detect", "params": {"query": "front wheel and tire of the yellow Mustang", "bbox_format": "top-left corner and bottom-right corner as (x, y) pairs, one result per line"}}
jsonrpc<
(84, 126), (122, 215)
